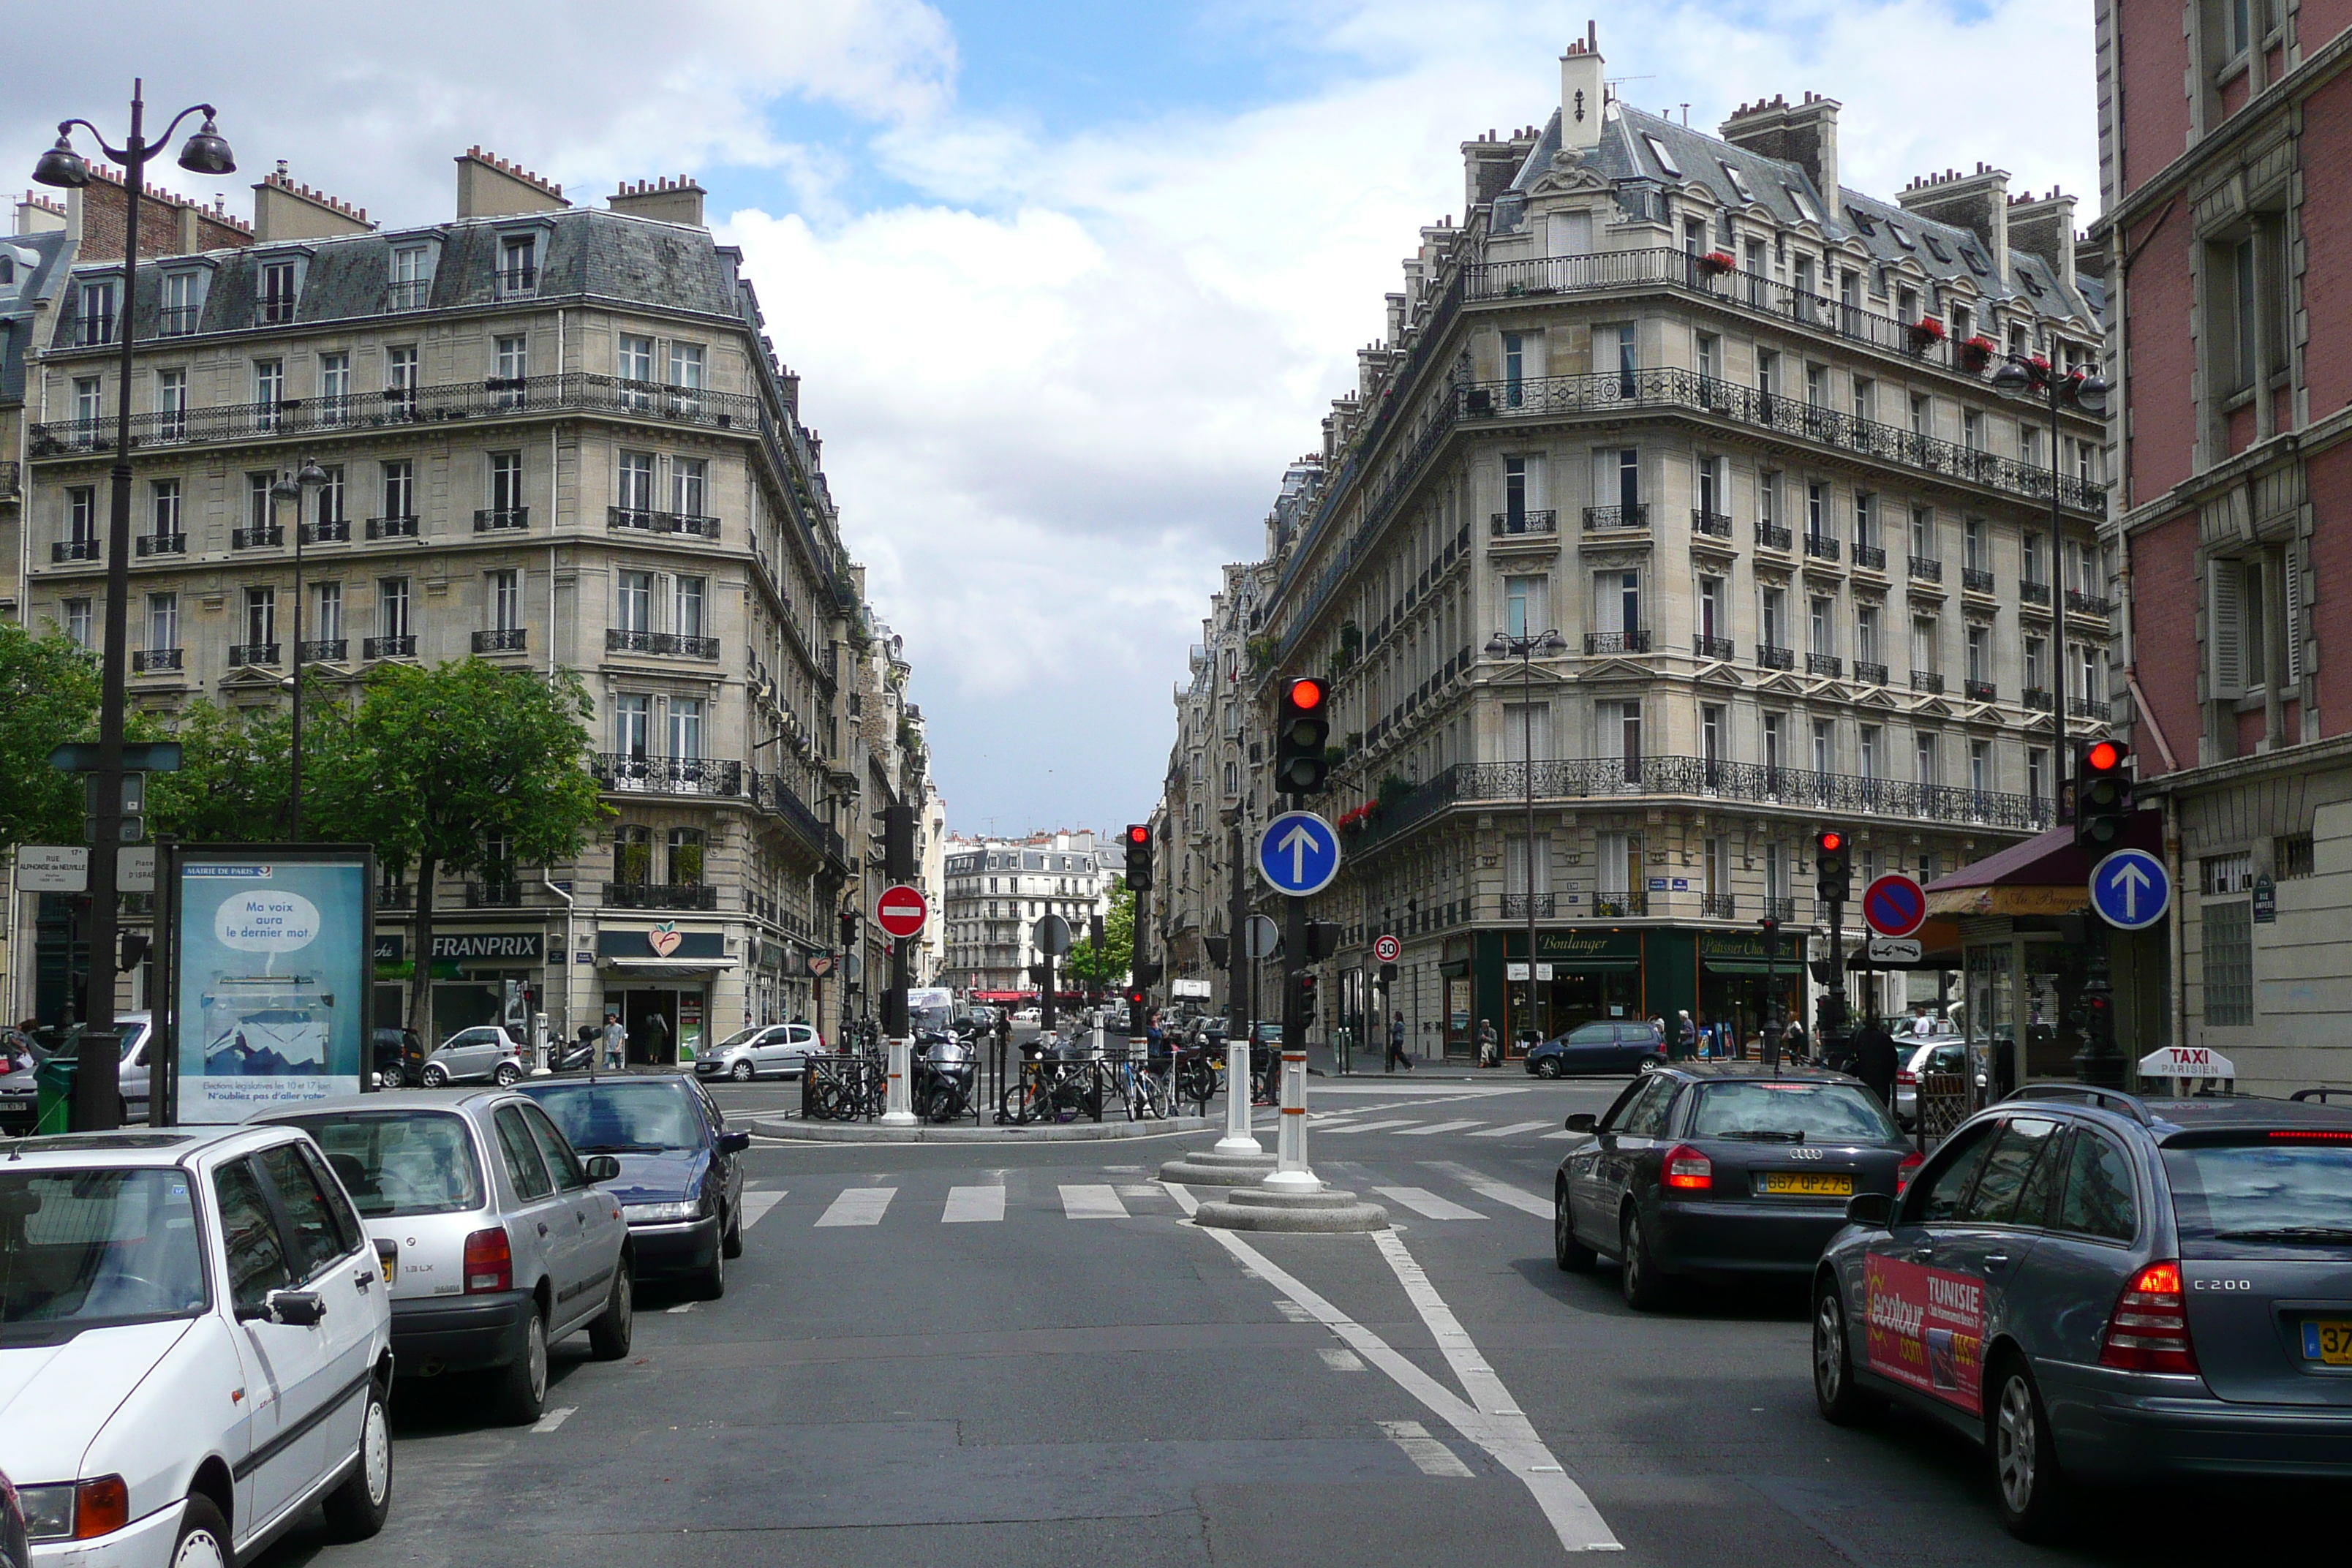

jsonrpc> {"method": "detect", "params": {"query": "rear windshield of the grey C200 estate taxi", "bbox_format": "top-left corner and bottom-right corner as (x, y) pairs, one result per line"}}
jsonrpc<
(2164, 1138), (2352, 1253)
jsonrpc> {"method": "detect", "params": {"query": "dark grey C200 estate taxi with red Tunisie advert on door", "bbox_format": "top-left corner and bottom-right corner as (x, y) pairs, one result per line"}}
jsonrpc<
(1811, 1084), (2352, 1539)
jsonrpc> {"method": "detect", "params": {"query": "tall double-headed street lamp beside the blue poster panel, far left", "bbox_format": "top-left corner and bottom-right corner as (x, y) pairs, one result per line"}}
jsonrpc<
(33, 80), (238, 1131)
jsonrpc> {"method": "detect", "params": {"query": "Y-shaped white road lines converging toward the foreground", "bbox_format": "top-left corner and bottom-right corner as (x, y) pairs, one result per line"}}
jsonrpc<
(1169, 1183), (1625, 1551)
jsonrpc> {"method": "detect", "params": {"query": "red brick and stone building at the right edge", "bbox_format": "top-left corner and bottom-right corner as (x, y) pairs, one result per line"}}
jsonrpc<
(2095, 0), (2352, 1088)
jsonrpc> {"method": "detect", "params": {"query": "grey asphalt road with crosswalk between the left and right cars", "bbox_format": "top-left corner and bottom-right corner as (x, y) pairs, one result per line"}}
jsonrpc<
(263, 1074), (2342, 1568)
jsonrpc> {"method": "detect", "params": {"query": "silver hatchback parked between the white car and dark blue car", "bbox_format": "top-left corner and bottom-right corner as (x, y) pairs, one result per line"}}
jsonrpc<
(257, 1088), (638, 1425)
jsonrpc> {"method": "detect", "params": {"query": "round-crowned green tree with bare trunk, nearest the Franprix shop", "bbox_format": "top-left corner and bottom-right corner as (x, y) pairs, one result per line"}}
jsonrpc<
(317, 658), (609, 1041)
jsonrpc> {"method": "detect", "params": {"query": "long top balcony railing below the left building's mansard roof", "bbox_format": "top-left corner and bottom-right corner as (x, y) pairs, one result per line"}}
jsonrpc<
(31, 372), (760, 459)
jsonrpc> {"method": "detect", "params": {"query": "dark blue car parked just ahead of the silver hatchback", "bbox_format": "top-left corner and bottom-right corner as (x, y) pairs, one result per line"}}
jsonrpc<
(522, 1072), (750, 1300)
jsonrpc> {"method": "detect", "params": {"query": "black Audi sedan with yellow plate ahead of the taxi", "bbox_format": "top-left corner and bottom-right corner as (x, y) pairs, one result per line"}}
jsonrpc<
(1553, 1063), (1919, 1312)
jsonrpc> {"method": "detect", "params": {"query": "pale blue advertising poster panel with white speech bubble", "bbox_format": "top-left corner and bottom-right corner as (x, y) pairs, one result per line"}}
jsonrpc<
(176, 848), (372, 1123)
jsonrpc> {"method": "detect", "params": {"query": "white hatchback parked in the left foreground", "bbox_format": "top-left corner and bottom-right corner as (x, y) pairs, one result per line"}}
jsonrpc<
(0, 1126), (393, 1568)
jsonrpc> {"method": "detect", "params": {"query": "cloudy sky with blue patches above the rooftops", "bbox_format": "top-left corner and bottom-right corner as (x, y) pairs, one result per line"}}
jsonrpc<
(0, 0), (2095, 832)
